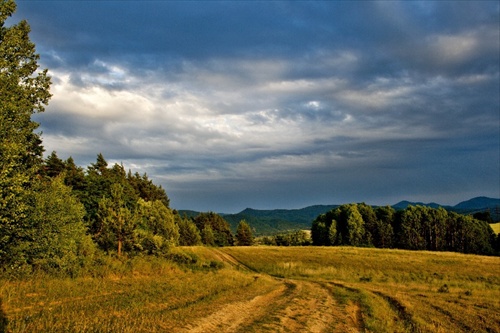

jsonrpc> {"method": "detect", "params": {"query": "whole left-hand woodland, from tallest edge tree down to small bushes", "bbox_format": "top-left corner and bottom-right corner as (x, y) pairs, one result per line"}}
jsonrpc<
(0, 0), (253, 274)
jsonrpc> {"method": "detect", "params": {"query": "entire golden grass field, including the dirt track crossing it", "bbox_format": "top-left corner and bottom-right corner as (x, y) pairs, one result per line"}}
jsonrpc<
(0, 247), (500, 332)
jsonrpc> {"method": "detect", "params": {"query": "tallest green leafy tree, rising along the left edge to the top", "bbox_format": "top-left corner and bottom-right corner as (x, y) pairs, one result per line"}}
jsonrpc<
(0, 0), (51, 264)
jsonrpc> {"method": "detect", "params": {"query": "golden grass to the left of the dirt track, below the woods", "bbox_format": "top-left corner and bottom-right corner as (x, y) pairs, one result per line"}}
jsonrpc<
(0, 248), (276, 333)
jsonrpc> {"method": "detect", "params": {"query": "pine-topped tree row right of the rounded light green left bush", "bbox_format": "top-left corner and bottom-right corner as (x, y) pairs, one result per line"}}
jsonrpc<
(47, 152), (253, 255)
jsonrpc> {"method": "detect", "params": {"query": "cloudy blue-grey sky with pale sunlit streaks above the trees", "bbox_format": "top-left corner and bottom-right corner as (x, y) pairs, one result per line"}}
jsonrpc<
(8, 1), (500, 213)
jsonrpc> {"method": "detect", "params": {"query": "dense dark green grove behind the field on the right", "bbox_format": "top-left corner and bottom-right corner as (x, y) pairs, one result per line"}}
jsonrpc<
(311, 203), (500, 255)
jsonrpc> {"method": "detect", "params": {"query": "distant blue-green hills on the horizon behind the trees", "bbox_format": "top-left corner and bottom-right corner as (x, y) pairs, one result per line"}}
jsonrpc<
(179, 197), (500, 236)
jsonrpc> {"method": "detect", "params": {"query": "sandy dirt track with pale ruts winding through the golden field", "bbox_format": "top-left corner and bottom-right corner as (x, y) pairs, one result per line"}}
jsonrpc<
(183, 249), (364, 333)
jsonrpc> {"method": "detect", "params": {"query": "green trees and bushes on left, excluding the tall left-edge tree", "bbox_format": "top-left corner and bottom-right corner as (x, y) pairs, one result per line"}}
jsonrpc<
(4, 150), (253, 274)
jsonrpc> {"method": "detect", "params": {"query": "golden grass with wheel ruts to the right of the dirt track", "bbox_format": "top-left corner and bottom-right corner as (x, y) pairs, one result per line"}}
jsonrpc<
(224, 247), (500, 332)
